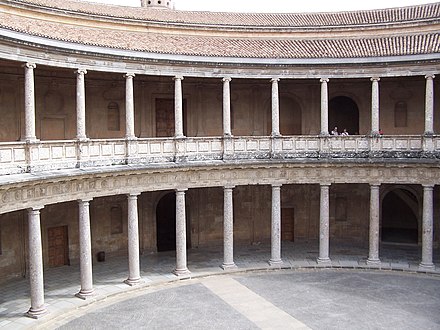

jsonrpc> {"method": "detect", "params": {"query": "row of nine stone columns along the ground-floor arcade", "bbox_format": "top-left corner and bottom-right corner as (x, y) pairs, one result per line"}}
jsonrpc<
(24, 183), (435, 318)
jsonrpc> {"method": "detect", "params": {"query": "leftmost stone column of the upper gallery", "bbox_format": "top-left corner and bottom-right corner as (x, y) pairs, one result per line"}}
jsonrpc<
(24, 63), (37, 142)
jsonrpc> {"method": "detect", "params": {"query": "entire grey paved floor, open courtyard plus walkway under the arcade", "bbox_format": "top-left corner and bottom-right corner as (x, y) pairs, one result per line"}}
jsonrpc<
(0, 242), (440, 329)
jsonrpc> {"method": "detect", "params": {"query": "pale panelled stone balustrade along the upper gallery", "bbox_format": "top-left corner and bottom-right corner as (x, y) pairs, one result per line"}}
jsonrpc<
(0, 135), (440, 175)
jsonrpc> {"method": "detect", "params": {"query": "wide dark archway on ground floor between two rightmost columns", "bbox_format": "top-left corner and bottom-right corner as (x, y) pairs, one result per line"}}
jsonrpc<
(382, 189), (418, 244)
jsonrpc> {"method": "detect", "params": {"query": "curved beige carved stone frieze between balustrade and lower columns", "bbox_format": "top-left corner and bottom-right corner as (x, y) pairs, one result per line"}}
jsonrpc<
(0, 162), (440, 213)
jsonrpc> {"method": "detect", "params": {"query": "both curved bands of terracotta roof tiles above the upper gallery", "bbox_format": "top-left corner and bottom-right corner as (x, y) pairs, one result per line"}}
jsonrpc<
(0, 0), (440, 59)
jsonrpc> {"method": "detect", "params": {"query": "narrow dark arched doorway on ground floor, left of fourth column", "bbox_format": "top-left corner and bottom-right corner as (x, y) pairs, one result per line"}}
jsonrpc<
(156, 192), (176, 252)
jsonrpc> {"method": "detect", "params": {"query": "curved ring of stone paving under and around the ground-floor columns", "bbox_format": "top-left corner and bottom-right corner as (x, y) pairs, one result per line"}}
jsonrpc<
(0, 242), (440, 329)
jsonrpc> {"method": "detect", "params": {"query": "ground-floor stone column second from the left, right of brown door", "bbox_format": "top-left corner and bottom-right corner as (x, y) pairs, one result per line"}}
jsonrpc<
(76, 199), (95, 299)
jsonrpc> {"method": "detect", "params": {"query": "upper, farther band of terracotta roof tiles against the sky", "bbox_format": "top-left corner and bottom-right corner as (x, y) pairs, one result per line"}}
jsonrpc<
(7, 0), (440, 27)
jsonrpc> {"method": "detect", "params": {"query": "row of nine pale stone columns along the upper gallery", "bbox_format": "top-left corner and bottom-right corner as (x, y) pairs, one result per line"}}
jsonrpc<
(24, 63), (435, 142)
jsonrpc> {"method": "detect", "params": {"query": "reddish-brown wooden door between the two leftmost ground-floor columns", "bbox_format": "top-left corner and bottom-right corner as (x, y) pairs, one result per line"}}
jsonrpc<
(47, 226), (69, 267)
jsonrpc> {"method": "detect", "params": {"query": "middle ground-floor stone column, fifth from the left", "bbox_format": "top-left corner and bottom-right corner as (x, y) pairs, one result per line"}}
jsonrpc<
(222, 186), (237, 269)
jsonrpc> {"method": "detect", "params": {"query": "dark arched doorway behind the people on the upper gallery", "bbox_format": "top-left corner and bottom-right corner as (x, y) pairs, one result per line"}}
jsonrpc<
(328, 96), (359, 135)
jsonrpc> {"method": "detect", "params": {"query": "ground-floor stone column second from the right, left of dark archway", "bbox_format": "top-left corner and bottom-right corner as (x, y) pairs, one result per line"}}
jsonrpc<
(367, 184), (380, 264)
